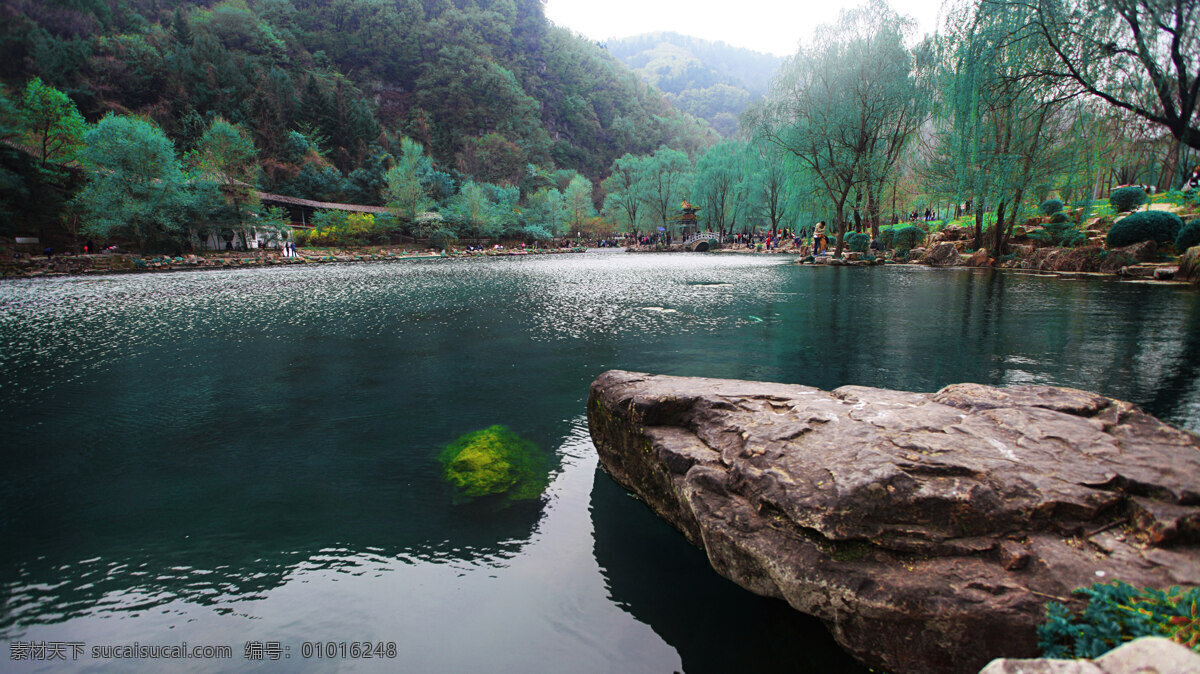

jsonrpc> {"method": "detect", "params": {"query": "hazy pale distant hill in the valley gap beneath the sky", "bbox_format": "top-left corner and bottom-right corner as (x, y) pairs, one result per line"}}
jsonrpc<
(605, 32), (784, 137)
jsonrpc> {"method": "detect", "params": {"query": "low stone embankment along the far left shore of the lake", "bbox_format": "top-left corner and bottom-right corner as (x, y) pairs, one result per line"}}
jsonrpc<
(0, 248), (582, 278)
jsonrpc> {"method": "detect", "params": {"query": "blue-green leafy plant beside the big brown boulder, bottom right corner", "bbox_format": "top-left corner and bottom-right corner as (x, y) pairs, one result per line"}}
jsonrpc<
(1038, 582), (1200, 658)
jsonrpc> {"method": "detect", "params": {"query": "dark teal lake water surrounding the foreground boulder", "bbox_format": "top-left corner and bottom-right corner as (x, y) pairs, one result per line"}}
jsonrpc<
(0, 252), (1200, 673)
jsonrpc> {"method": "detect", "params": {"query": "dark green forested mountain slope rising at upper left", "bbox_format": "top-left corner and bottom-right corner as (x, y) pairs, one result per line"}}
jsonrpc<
(0, 0), (714, 199)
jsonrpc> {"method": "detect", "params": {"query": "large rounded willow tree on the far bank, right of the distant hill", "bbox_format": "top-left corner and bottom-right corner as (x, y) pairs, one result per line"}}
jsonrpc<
(750, 0), (917, 257)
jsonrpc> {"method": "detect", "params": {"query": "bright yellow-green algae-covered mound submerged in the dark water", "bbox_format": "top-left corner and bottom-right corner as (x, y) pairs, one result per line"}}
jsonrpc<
(438, 426), (550, 501)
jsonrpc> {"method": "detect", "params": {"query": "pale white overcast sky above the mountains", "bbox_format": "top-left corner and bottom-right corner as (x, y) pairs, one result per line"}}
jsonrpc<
(546, 0), (941, 56)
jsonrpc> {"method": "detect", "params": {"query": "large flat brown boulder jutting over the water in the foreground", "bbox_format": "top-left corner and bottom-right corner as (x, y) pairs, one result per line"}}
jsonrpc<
(588, 371), (1200, 673)
